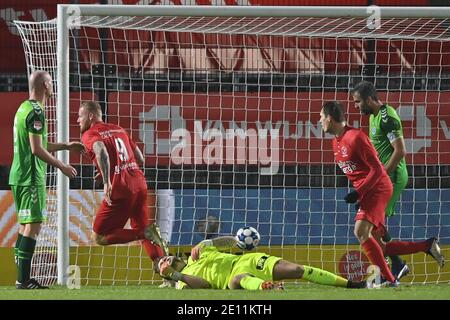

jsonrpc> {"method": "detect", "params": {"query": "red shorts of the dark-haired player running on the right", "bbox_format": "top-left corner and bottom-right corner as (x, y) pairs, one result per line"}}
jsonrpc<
(355, 179), (393, 233)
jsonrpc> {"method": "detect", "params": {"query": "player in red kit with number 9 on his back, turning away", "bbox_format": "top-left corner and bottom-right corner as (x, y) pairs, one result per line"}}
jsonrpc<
(77, 101), (167, 261)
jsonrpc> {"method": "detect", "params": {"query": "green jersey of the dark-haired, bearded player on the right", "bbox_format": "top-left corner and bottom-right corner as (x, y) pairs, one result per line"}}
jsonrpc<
(369, 104), (406, 169)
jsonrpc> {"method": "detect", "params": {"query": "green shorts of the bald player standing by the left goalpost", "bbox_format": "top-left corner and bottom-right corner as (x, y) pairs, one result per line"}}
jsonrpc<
(11, 186), (47, 224)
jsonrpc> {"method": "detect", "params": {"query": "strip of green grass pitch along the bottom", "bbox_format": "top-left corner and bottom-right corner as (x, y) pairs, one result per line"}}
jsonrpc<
(0, 284), (450, 301)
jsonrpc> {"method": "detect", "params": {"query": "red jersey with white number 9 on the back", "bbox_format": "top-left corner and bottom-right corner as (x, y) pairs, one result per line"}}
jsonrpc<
(81, 122), (147, 199)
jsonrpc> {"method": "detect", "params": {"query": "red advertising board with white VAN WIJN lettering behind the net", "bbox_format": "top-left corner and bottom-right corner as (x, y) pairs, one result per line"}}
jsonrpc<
(103, 92), (450, 166)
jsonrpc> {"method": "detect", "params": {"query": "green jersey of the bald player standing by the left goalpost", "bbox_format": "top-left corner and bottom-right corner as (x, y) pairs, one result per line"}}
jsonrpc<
(9, 100), (47, 186)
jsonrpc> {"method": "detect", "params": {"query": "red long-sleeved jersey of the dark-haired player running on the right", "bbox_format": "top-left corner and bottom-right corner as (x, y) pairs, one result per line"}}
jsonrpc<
(333, 126), (391, 198)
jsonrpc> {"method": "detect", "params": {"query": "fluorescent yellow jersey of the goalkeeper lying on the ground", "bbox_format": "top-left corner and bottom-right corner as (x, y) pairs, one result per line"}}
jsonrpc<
(177, 246), (241, 289)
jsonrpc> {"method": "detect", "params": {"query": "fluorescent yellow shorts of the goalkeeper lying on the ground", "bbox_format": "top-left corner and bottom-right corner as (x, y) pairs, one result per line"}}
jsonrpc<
(230, 253), (281, 281)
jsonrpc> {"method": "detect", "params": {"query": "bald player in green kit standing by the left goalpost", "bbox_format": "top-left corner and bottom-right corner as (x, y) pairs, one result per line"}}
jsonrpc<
(9, 71), (84, 289)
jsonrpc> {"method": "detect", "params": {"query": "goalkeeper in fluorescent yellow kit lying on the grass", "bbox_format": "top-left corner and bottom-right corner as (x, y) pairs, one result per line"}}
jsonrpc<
(154, 236), (366, 290)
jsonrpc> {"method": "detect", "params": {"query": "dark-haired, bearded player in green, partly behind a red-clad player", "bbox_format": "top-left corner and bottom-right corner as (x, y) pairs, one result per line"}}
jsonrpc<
(351, 81), (409, 279)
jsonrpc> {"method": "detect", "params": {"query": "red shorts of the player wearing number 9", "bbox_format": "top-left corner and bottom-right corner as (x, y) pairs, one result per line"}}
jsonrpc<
(93, 189), (149, 235)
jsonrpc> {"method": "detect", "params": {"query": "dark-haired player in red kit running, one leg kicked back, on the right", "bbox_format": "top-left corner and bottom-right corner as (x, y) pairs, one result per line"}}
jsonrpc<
(320, 101), (445, 286)
